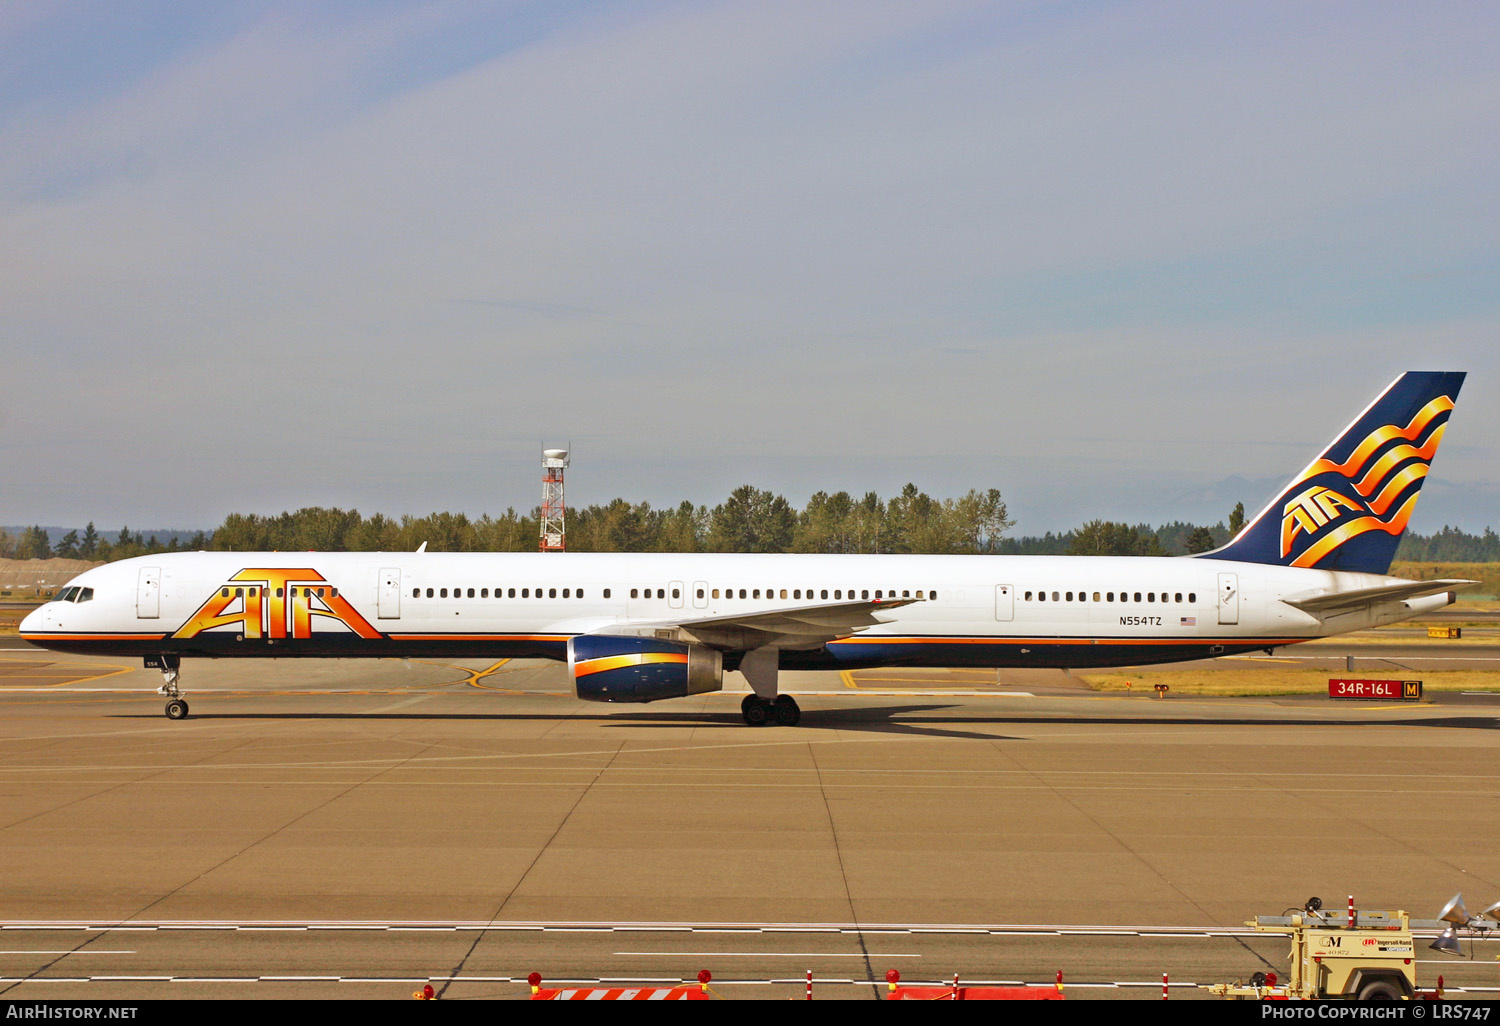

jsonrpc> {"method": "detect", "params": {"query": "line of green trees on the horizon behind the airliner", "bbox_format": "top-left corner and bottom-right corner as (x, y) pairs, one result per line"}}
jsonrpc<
(0, 495), (1500, 563)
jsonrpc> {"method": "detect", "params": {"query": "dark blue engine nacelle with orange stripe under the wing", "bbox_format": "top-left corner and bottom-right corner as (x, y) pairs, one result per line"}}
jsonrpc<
(567, 635), (725, 702)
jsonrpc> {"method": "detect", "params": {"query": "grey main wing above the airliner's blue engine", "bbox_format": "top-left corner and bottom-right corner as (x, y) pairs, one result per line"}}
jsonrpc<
(594, 599), (923, 650)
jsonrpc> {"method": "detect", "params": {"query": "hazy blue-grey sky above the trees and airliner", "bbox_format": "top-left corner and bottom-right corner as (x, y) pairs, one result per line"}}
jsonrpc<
(0, 0), (1500, 533)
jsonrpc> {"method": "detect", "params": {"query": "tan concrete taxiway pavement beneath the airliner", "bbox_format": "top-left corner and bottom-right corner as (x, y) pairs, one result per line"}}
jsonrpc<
(0, 642), (1500, 999)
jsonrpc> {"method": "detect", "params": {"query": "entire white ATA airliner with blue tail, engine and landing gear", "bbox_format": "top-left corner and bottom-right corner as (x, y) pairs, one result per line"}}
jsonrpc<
(21, 372), (1475, 726)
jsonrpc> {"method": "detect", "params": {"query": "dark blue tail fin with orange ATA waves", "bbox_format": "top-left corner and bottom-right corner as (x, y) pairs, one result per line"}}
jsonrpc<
(1202, 371), (1464, 573)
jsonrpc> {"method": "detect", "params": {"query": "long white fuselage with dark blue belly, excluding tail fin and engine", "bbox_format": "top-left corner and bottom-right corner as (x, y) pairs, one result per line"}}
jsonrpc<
(23, 552), (1452, 669)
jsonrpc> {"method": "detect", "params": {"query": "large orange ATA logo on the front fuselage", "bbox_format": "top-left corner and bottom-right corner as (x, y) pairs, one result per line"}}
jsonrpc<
(173, 567), (381, 639)
